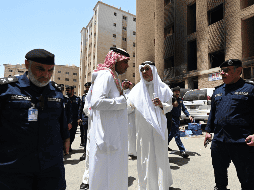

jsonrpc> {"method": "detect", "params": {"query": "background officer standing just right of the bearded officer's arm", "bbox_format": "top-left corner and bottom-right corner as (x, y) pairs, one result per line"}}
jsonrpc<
(66, 86), (80, 152)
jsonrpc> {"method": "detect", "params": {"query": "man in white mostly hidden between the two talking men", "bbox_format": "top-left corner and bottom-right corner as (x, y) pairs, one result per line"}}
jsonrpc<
(122, 79), (137, 160)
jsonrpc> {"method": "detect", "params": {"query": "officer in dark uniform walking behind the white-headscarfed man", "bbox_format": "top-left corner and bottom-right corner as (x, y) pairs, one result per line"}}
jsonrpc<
(168, 86), (193, 158)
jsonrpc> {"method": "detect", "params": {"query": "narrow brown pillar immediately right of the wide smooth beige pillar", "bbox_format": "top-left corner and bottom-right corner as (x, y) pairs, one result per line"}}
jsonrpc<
(155, 0), (164, 79)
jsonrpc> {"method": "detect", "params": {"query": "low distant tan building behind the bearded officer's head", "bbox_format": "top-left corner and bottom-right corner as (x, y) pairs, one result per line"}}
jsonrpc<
(4, 64), (79, 95)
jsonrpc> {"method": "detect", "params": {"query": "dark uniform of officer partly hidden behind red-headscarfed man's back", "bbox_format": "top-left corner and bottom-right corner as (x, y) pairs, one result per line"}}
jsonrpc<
(78, 94), (88, 150)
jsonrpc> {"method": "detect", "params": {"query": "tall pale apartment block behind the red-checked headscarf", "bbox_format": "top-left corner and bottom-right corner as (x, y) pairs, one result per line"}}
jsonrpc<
(79, 1), (136, 94)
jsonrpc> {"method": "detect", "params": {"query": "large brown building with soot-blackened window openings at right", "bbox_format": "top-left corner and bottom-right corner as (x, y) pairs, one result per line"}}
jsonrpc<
(136, 0), (254, 89)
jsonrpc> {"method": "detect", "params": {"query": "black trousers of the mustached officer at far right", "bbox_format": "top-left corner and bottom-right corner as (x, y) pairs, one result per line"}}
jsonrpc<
(211, 141), (254, 190)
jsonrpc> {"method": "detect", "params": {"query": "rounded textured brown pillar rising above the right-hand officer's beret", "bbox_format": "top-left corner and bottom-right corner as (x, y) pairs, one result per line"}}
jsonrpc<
(224, 0), (242, 60)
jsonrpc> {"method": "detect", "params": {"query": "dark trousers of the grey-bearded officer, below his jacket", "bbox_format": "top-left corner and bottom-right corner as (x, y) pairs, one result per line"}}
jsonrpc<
(0, 163), (66, 190)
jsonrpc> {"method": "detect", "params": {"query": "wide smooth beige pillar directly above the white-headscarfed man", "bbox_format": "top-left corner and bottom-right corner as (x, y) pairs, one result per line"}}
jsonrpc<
(135, 0), (155, 84)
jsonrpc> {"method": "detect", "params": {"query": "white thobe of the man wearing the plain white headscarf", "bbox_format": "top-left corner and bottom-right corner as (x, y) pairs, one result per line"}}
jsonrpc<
(128, 84), (173, 190)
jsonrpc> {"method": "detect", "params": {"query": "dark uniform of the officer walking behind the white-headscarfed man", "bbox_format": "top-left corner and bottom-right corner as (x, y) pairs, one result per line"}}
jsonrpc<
(168, 97), (190, 152)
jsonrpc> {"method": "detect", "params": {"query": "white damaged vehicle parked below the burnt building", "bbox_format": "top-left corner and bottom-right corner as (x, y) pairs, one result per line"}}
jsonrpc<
(181, 88), (214, 122)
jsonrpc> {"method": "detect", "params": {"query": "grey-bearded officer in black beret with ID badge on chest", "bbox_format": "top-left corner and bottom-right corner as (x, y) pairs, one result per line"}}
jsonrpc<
(0, 49), (70, 190)
